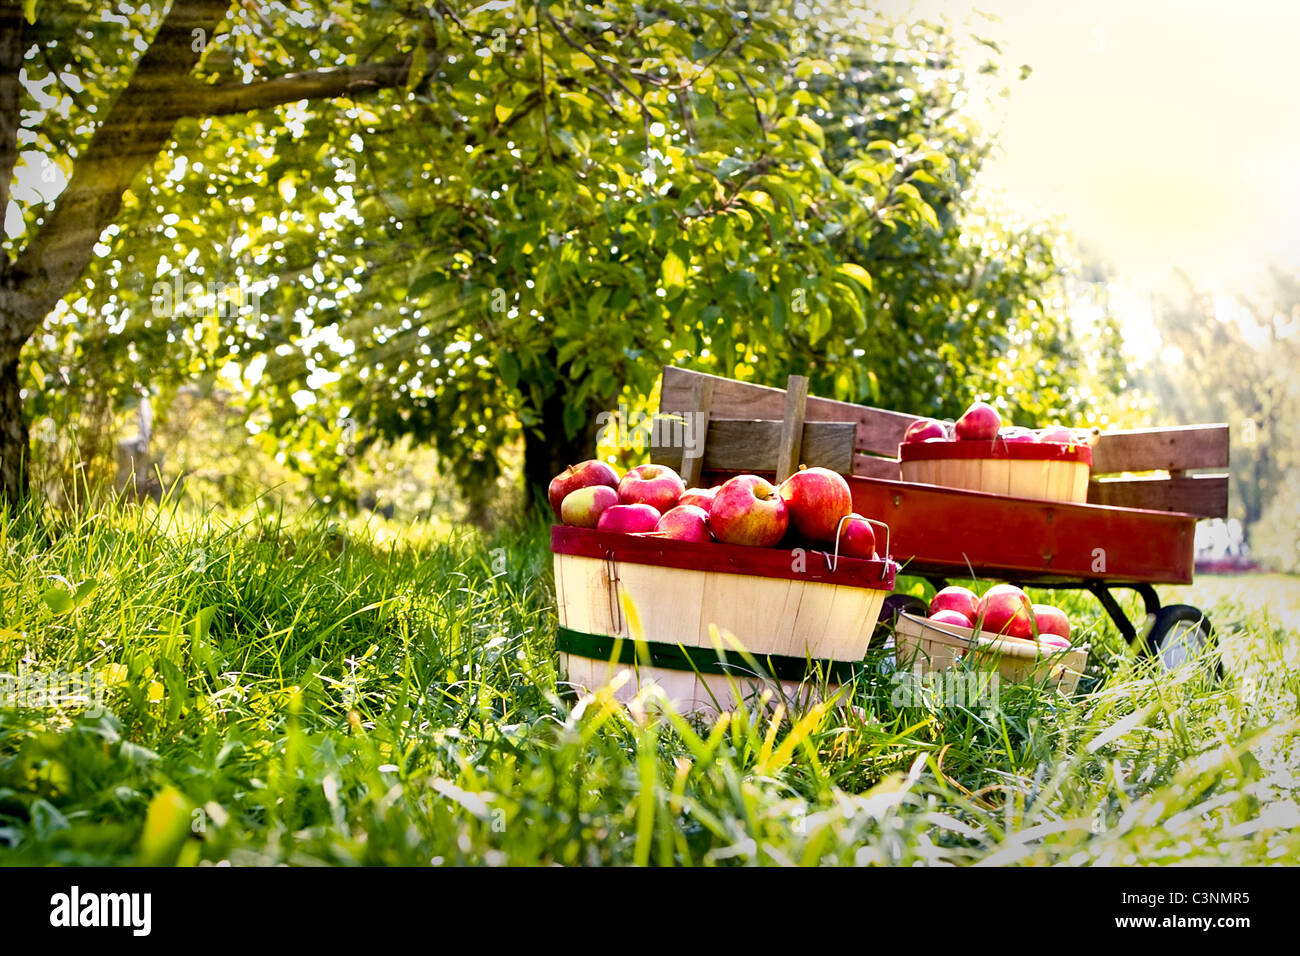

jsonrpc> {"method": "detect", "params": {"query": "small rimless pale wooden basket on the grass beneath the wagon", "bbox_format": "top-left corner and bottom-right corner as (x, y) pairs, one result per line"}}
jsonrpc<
(894, 611), (1089, 693)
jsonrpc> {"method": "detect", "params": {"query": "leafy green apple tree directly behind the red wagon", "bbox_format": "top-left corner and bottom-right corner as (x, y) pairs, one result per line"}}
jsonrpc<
(244, 3), (1107, 502)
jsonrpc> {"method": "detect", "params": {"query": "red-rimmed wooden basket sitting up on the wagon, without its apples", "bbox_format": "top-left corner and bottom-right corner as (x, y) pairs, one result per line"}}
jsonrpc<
(898, 438), (1092, 505)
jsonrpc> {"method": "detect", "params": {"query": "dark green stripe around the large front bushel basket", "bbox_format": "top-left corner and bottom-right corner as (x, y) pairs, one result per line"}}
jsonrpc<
(555, 627), (862, 684)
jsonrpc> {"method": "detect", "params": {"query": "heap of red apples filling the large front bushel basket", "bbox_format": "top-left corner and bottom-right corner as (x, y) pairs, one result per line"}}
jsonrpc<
(547, 459), (876, 559)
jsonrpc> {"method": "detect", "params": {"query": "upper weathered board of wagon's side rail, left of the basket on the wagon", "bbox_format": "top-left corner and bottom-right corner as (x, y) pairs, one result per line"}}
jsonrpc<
(659, 365), (918, 455)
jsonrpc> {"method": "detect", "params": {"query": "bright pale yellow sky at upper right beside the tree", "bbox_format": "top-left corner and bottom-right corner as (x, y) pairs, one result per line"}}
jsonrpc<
(880, 0), (1300, 287)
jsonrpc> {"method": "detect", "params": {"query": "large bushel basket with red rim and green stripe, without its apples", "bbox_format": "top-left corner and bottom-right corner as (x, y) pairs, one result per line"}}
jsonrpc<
(551, 525), (898, 713)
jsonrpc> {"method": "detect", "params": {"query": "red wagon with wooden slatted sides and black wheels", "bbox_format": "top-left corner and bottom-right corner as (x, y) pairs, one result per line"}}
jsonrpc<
(651, 367), (1229, 666)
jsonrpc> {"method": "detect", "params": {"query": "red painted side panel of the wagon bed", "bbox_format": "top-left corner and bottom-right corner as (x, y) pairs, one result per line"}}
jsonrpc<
(846, 476), (1196, 584)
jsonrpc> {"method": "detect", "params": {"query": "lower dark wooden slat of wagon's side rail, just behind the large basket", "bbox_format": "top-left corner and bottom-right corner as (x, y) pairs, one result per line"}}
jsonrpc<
(650, 418), (854, 475)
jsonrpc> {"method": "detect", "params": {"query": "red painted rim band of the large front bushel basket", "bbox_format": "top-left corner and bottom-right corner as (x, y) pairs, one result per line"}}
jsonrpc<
(551, 524), (898, 591)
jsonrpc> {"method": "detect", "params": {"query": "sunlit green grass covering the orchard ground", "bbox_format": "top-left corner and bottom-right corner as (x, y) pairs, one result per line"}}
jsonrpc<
(0, 510), (1300, 865)
